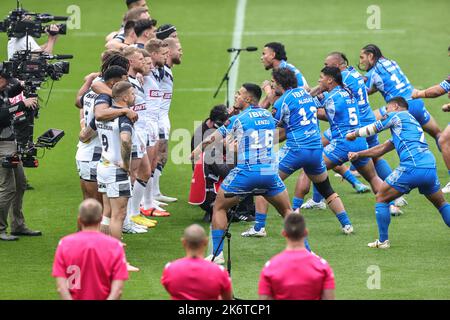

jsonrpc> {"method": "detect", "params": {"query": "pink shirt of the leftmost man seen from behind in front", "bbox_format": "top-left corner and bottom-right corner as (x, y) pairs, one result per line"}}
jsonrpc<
(52, 231), (128, 300)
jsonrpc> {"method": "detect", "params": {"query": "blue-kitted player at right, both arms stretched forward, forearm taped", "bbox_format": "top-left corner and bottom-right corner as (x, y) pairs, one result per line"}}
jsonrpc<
(346, 97), (450, 249)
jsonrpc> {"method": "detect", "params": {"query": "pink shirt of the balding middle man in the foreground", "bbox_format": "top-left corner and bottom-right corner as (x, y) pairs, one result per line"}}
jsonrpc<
(161, 258), (231, 300)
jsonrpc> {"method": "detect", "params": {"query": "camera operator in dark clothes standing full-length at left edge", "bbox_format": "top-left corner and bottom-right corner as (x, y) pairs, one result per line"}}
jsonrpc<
(0, 64), (42, 241)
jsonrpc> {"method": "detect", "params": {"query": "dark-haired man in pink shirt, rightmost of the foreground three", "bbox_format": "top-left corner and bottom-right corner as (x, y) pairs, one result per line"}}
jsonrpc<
(258, 213), (334, 300)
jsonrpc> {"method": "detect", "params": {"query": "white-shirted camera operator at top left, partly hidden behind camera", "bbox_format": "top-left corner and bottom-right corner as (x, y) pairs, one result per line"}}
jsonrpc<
(8, 16), (59, 60)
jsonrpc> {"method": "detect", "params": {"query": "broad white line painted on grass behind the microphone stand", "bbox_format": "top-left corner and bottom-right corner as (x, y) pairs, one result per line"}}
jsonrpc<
(229, 0), (247, 106)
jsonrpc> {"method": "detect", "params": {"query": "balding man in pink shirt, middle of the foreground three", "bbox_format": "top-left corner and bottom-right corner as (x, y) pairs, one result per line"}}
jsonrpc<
(161, 224), (233, 300)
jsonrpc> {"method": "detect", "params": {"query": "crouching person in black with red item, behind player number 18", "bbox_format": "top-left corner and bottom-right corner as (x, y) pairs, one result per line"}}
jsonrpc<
(189, 104), (255, 222)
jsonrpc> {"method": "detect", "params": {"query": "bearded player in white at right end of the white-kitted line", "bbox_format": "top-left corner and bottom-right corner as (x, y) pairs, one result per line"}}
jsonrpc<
(152, 37), (183, 202)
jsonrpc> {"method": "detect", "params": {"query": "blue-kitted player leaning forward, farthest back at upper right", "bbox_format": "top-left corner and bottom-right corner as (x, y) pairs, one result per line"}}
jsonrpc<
(359, 44), (441, 150)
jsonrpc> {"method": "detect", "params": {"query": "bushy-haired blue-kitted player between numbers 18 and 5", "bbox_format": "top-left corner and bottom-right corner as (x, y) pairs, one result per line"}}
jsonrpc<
(242, 68), (353, 237)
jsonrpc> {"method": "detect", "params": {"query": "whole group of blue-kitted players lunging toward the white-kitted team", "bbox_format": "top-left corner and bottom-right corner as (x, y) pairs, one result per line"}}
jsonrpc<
(192, 42), (450, 263)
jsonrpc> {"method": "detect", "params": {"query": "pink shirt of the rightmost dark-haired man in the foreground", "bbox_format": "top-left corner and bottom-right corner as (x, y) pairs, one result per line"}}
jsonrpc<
(258, 249), (334, 300)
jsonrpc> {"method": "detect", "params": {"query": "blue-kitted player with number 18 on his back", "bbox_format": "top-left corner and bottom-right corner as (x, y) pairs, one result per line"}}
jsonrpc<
(191, 83), (292, 264)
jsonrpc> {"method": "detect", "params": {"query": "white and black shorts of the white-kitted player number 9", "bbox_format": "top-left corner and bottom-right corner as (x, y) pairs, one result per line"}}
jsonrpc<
(97, 163), (131, 198)
